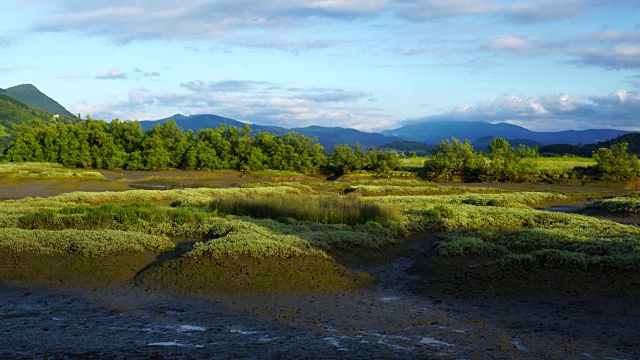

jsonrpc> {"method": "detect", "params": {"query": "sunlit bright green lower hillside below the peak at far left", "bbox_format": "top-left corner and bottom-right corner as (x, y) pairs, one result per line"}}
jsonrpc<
(0, 94), (80, 150)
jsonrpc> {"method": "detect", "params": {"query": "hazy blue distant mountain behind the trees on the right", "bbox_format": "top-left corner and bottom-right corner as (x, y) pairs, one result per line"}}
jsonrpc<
(382, 121), (628, 145)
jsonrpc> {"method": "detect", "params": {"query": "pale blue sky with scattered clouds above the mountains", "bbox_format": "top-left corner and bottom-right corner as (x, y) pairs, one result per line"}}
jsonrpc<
(0, 0), (640, 131)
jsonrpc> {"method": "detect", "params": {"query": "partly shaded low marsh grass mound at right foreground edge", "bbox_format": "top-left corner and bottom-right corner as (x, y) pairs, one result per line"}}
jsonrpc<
(438, 214), (640, 270)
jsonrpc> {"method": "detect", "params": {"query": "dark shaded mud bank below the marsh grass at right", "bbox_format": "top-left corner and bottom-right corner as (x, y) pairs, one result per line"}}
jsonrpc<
(409, 255), (640, 301)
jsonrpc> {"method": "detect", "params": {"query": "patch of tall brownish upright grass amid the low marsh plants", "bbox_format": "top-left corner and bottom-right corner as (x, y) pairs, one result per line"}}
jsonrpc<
(209, 194), (402, 225)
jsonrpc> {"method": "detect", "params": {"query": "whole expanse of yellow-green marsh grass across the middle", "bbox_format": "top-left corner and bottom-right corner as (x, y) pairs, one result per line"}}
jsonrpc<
(0, 179), (640, 269)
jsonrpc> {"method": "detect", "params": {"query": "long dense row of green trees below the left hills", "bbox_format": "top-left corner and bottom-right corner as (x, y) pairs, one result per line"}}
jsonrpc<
(4, 119), (399, 174)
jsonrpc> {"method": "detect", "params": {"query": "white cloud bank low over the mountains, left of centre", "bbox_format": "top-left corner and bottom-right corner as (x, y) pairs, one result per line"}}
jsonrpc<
(74, 80), (393, 131)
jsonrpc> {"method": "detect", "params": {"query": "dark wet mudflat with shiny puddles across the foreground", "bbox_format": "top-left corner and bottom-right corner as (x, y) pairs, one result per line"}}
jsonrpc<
(0, 237), (640, 359)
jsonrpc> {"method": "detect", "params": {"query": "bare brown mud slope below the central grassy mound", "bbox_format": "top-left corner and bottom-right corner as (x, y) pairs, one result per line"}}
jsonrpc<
(135, 257), (375, 294)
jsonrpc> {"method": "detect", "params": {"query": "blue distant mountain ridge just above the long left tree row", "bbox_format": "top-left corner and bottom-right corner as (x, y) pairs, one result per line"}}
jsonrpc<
(140, 114), (400, 151)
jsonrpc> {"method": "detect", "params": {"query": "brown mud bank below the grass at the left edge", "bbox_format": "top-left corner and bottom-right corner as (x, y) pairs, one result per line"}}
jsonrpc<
(0, 251), (156, 288)
